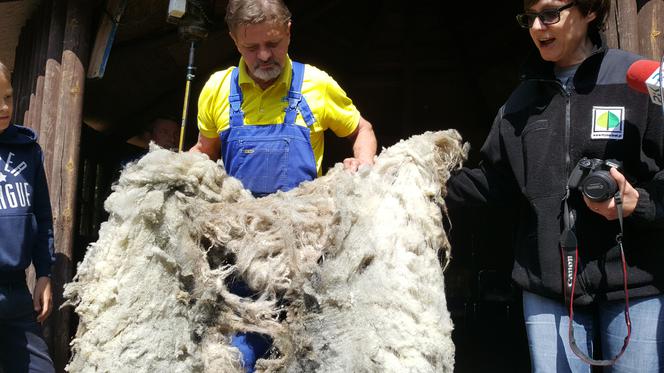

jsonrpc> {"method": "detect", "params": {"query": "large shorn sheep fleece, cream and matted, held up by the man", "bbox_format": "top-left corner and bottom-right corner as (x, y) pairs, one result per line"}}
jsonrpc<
(66, 130), (467, 372)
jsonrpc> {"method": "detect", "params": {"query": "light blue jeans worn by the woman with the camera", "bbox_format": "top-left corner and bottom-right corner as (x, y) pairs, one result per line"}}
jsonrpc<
(523, 291), (664, 373)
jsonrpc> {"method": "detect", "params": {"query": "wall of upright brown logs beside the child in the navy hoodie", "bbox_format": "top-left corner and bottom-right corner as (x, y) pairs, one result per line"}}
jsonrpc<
(12, 0), (98, 372)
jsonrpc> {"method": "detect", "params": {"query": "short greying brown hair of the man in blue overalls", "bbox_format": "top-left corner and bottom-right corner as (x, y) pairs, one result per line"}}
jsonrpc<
(225, 0), (291, 33)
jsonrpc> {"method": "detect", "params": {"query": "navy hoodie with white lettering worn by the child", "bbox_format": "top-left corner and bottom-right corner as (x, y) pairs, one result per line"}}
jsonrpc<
(0, 125), (55, 283)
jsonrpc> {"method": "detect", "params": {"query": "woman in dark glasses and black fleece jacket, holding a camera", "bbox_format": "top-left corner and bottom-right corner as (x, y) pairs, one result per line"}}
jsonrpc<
(446, 0), (664, 372)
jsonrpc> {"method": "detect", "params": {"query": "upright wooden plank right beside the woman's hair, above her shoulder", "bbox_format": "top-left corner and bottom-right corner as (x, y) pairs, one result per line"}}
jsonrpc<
(606, 0), (639, 53)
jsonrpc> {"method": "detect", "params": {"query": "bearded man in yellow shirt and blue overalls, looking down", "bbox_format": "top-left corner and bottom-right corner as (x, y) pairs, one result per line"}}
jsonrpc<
(191, 0), (376, 197)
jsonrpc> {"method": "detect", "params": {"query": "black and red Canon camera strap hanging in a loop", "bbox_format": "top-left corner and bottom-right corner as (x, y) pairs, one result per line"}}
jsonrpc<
(560, 191), (632, 366)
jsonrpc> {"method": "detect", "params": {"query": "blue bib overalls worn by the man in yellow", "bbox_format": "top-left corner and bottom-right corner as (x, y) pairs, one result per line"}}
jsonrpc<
(219, 61), (317, 197)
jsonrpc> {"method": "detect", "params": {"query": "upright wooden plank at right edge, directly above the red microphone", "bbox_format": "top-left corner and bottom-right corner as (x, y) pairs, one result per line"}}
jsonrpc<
(638, 0), (664, 60)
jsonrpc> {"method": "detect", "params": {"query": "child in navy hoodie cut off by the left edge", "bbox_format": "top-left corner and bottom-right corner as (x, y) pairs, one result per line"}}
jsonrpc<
(0, 62), (55, 372)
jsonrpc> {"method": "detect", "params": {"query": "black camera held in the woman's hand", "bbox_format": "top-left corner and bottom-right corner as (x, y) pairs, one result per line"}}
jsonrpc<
(567, 157), (622, 202)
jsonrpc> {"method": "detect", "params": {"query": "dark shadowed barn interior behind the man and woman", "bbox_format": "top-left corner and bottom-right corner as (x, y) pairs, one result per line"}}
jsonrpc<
(75, 0), (534, 372)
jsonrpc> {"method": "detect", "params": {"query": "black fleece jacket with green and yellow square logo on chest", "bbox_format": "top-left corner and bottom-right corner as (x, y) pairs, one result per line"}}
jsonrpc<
(446, 37), (664, 305)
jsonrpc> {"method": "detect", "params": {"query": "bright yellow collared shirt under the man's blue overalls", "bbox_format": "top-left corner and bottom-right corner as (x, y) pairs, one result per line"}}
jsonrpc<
(198, 59), (360, 175)
